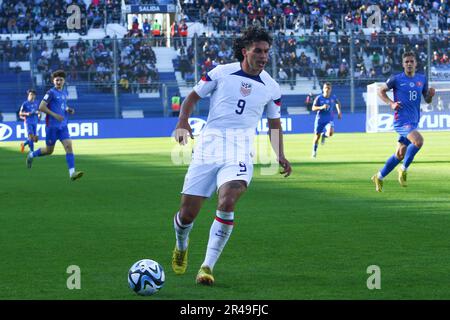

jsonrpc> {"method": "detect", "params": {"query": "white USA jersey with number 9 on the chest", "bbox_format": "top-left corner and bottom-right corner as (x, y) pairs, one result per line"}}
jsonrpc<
(193, 62), (281, 163)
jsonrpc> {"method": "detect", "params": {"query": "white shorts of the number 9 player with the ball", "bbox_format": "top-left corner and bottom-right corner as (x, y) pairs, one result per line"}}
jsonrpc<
(181, 160), (253, 198)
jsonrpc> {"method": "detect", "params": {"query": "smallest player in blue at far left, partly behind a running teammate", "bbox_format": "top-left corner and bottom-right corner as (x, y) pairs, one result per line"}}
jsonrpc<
(19, 89), (41, 152)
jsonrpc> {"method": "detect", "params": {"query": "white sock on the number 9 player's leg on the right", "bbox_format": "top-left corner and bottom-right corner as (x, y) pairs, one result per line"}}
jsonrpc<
(202, 210), (234, 270)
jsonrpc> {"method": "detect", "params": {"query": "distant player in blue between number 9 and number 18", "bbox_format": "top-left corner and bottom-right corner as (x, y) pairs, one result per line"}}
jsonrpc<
(311, 82), (342, 158)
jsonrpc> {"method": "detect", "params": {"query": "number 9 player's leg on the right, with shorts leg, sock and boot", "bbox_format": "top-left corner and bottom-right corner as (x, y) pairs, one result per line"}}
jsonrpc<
(196, 162), (253, 285)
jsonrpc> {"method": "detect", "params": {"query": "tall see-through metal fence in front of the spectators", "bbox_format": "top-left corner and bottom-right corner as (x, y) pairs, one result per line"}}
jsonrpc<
(0, 30), (450, 117)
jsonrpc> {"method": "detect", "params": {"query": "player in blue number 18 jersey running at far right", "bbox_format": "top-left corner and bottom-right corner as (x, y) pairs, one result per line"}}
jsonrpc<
(372, 52), (435, 192)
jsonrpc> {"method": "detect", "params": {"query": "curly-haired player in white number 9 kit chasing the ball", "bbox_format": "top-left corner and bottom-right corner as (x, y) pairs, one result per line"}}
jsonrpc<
(172, 26), (292, 285)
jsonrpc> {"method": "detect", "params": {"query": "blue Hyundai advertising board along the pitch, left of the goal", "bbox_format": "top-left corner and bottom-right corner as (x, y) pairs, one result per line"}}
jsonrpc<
(0, 113), (366, 141)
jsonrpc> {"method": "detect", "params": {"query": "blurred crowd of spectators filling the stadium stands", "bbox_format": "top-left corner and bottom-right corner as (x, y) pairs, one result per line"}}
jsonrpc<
(0, 0), (450, 92)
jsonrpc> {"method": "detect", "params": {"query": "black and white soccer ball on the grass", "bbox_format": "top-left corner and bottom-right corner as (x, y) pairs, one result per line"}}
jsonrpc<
(128, 259), (165, 296)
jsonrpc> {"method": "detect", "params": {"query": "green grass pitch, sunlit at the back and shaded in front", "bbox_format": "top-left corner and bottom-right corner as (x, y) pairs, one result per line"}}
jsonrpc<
(0, 132), (450, 300)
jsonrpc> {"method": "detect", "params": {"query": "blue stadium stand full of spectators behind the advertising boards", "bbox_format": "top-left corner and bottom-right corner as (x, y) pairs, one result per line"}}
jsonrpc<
(0, 0), (450, 118)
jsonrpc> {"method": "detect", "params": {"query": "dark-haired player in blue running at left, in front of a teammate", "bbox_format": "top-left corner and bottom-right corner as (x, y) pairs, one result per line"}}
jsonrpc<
(27, 70), (83, 181)
